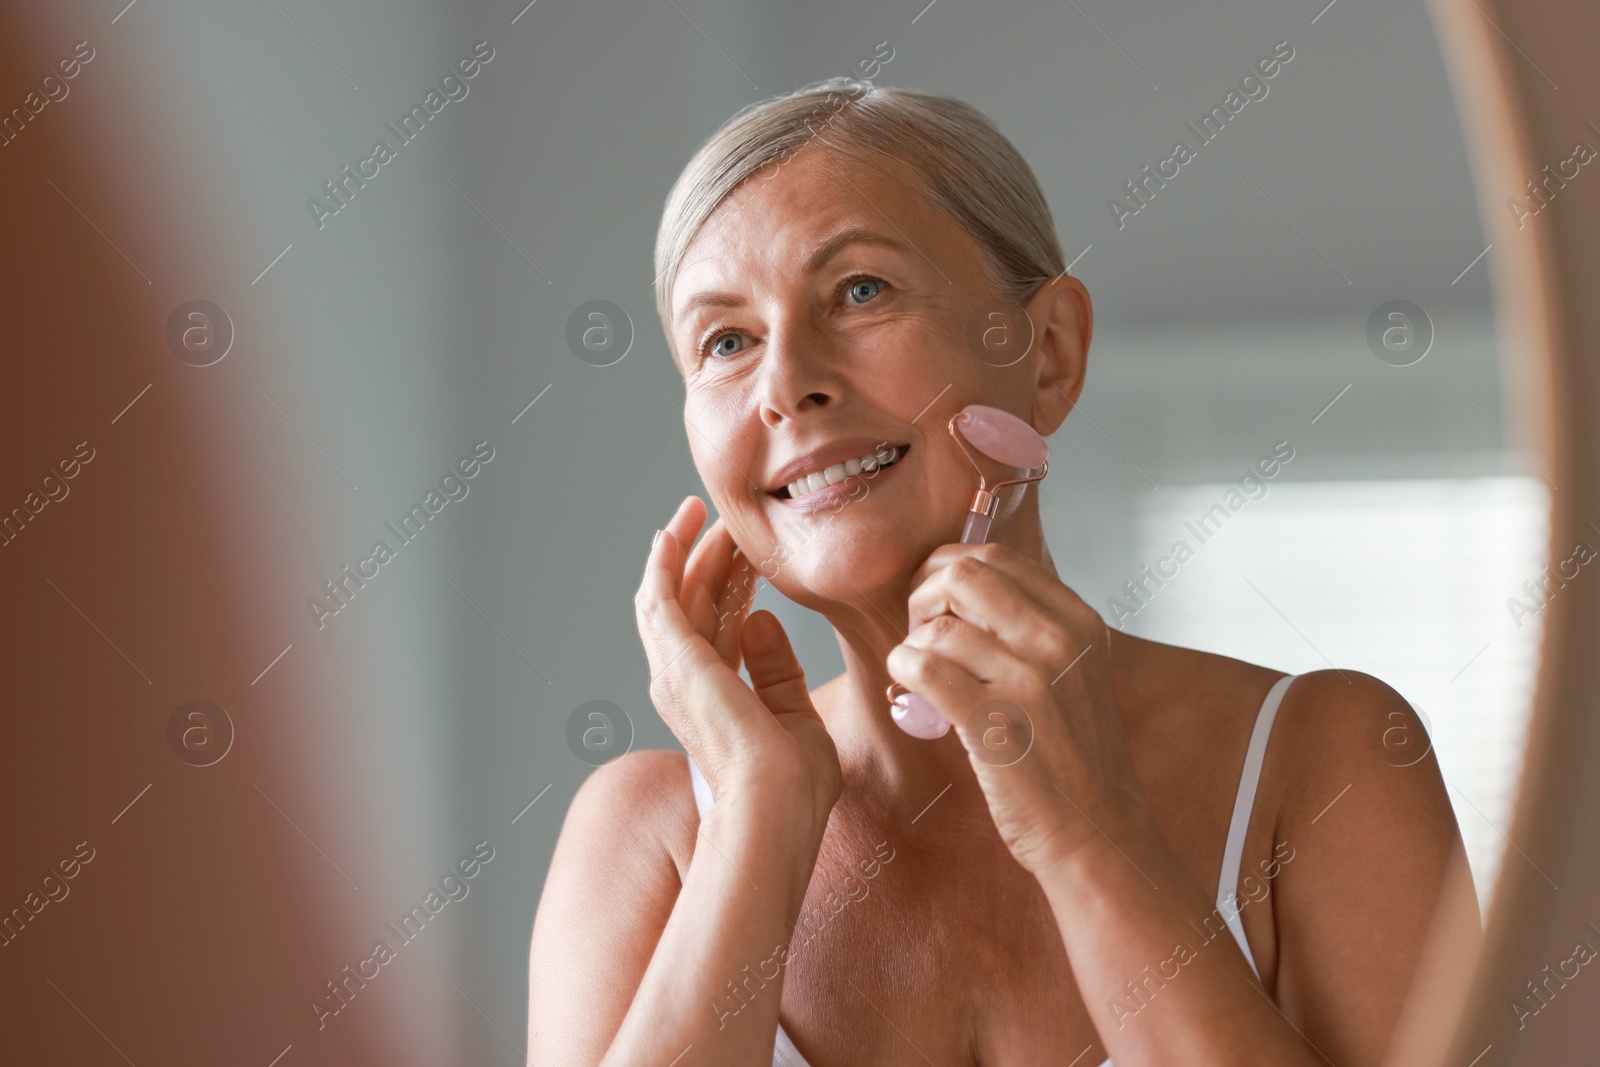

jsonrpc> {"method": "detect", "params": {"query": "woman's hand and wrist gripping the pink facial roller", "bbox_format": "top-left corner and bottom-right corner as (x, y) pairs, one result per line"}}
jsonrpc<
(888, 544), (1146, 877)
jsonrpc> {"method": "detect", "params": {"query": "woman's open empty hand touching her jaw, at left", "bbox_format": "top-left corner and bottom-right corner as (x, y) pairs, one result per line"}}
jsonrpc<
(634, 496), (843, 841)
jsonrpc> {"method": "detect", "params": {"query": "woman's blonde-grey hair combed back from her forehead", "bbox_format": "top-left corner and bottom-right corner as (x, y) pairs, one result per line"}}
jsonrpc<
(654, 77), (1066, 358)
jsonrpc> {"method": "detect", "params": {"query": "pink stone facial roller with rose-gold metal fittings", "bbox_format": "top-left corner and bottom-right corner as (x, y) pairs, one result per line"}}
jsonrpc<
(888, 403), (1050, 739)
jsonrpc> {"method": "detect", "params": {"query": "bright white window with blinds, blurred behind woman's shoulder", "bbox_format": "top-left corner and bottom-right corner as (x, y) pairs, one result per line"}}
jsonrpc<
(1126, 477), (1548, 909)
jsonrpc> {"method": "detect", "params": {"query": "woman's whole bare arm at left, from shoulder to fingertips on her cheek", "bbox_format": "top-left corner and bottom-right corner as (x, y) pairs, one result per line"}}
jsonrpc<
(528, 496), (842, 1067)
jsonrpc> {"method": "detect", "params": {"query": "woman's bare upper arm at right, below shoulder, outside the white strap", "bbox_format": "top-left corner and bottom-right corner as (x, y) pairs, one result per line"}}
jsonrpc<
(1254, 670), (1482, 1067)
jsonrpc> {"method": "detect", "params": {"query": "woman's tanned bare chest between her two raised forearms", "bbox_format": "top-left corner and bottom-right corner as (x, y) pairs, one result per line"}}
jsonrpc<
(768, 798), (1094, 1067)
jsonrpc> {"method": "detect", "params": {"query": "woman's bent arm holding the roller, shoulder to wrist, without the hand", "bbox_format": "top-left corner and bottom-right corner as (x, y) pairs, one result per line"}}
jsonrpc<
(1040, 672), (1475, 1067)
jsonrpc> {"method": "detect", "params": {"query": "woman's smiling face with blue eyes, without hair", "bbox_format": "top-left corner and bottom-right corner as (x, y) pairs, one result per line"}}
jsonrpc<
(672, 147), (1077, 608)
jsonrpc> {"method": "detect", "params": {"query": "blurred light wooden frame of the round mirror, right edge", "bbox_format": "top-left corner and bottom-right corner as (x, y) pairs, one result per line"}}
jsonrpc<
(1408, 0), (1600, 1067)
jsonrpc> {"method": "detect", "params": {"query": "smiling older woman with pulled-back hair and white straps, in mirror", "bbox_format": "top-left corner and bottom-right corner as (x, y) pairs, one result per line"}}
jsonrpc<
(530, 80), (1461, 1067)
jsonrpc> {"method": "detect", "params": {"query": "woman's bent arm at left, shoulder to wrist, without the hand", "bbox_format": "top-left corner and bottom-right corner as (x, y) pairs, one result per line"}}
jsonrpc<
(528, 752), (819, 1067)
